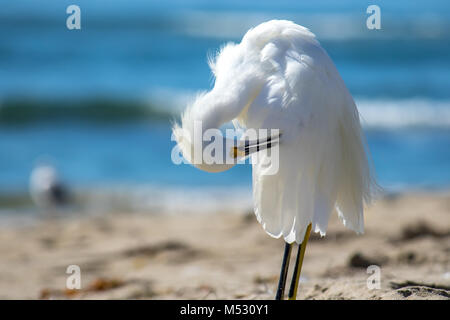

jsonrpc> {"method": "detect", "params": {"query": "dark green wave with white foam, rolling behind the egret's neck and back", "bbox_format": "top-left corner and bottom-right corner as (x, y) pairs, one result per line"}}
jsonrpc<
(0, 95), (450, 129)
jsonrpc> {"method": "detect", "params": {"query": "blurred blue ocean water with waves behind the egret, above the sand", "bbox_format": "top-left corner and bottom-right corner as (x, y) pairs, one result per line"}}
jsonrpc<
(0, 0), (450, 218)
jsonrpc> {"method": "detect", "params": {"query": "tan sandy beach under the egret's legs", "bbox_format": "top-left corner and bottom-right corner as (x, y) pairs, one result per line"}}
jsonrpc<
(0, 192), (450, 299)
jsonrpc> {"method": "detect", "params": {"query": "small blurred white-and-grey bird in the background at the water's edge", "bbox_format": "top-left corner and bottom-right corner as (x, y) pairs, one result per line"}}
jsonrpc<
(30, 164), (68, 211)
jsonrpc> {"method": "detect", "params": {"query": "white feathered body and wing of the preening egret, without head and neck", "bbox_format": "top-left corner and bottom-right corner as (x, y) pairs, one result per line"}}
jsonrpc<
(242, 21), (375, 243)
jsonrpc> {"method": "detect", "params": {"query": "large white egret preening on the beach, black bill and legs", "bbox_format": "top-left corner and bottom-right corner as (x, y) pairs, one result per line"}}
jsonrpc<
(173, 20), (376, 299)
